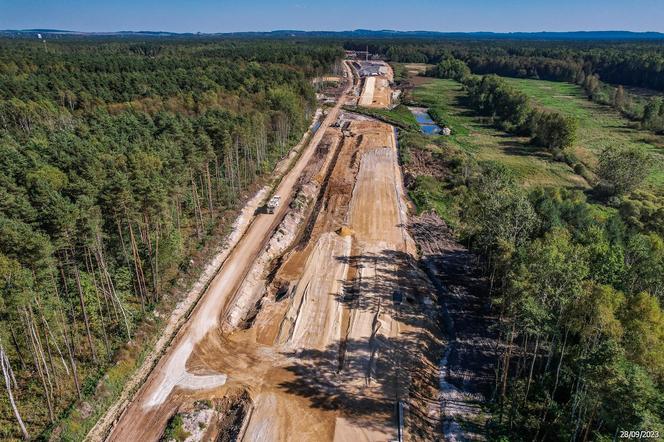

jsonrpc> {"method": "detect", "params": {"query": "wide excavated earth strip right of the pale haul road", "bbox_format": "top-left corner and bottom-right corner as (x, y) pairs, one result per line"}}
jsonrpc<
(174, 114), (443, 441)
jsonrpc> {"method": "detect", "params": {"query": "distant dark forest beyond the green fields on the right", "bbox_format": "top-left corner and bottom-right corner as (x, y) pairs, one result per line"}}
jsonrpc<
(356, 40), (664, 132)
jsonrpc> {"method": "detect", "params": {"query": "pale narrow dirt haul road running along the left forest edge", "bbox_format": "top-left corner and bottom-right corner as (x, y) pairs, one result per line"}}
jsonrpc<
(88, 64), (353, 441)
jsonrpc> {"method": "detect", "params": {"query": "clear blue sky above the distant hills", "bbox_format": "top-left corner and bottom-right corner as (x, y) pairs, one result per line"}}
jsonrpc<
(0, 0), (664, 32)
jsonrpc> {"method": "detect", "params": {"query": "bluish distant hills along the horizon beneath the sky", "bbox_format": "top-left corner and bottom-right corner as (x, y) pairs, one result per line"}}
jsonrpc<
(0, 29), (664, 41)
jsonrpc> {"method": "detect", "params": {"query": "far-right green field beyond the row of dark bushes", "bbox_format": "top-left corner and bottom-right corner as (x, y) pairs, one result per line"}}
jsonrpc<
(505, 78), (664, 187)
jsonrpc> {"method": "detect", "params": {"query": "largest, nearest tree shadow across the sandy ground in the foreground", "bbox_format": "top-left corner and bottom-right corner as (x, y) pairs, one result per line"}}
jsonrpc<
(279, 332), (443, 434)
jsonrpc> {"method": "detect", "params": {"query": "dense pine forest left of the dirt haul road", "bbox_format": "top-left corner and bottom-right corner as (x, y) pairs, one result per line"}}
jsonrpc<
(0, 40), (341, 438)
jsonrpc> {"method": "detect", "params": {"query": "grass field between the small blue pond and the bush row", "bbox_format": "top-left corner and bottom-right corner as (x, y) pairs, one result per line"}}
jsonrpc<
(409, 79), (588, 188)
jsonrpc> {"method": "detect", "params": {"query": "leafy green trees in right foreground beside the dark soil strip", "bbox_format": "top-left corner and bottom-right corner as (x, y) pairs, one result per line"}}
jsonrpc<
(461, 164), (664, 441)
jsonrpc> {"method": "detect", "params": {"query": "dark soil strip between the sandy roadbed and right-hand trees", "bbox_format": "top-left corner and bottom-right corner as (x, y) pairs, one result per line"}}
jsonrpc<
(409, 213), (498, 441)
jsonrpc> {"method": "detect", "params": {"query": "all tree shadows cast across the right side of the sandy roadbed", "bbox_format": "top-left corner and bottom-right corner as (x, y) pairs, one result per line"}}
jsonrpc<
(280, 250), (444, 439)
